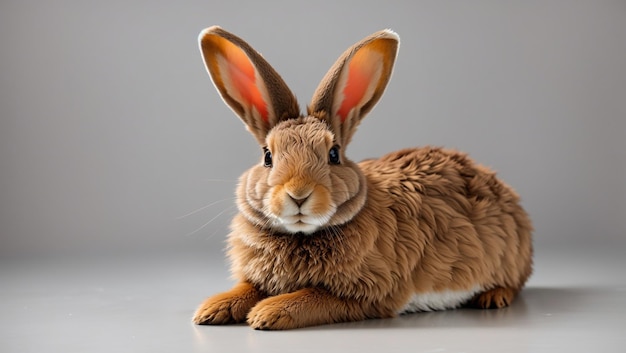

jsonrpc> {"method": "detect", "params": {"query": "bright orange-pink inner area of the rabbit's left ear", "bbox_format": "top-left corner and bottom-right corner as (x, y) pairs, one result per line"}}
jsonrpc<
(225, 46), (269, 122)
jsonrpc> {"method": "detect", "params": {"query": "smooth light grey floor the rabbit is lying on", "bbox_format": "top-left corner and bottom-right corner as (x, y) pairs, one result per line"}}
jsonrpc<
(0, 243), (626, 352)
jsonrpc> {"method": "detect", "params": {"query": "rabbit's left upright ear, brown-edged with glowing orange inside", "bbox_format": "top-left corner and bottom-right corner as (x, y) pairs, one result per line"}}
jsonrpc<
(198, 26), (300, 144)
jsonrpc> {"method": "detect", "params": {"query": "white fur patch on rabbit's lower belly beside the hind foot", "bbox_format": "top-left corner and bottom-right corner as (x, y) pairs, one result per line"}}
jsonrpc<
(398, 286), (480, 314)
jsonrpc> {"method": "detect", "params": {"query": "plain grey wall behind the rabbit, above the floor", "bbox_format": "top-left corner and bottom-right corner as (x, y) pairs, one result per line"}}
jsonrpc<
(0, 1), (626, 255)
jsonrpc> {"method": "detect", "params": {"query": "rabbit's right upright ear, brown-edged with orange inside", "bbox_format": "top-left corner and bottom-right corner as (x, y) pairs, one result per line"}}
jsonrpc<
(308, 29), (400, 144)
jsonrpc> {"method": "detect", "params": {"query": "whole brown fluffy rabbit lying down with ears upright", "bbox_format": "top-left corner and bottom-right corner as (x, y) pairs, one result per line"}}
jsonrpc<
(192, 26), (533, 330)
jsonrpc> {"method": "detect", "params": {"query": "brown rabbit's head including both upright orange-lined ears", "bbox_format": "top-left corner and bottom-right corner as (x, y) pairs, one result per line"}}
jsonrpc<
(199, 27), (399, 234)
